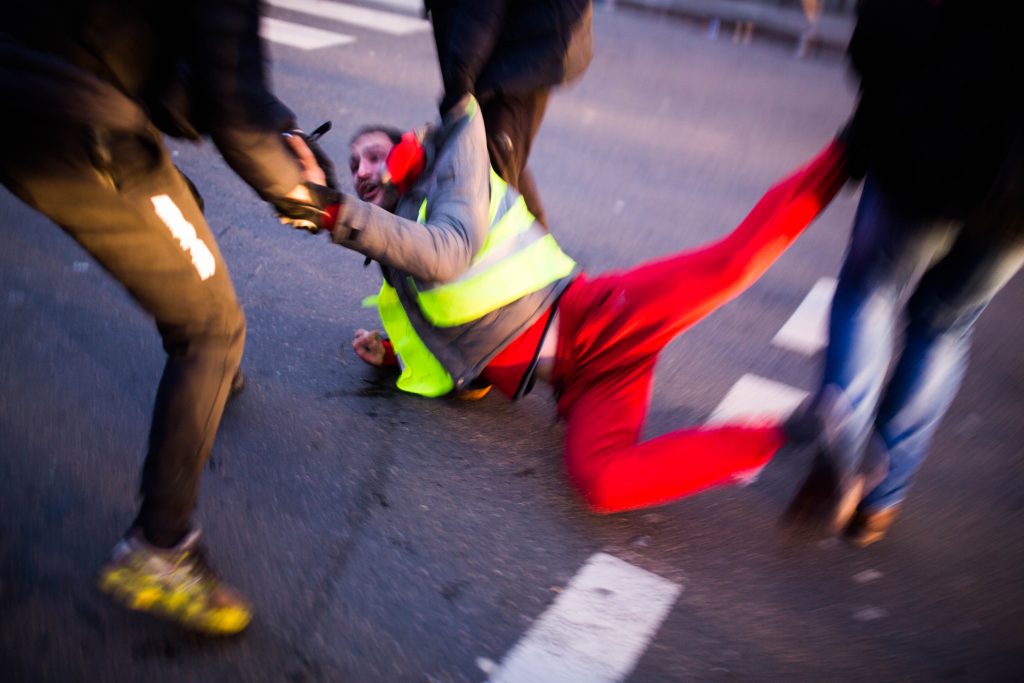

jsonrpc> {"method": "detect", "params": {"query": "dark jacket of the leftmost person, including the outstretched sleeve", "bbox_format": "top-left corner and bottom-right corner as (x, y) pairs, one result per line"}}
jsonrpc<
(0, 0), (299, 199)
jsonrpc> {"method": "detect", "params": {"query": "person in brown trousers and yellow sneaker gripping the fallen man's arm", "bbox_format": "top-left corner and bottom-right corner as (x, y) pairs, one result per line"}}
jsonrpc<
(0, 0), (337, 634)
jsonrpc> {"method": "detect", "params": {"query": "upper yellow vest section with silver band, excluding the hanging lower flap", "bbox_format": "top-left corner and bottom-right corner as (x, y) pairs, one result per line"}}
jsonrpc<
(413, 169), (575, 328)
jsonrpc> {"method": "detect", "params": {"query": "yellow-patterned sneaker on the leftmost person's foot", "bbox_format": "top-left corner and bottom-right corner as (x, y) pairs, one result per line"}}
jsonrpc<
(99, 529), (252, 636)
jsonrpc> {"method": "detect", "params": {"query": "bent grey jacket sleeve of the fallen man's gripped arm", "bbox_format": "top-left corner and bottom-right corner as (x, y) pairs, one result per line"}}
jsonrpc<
(339, 98), (489, 283)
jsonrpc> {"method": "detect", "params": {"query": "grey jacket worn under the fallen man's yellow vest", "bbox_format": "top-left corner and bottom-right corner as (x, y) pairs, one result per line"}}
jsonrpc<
(339, 96), (575, 390)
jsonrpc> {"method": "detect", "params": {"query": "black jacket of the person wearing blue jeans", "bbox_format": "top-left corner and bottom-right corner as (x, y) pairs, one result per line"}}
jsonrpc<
(846, 0), (1024, 224)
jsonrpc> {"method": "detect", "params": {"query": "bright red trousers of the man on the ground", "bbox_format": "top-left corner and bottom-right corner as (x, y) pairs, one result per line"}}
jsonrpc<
(553, 142), (846, 513)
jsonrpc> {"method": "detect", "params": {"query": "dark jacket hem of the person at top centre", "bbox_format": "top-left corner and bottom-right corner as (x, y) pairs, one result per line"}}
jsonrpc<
(424, 0), (594, 112)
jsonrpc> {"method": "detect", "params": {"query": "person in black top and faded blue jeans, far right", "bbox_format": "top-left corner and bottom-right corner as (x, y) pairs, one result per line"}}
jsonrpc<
(788, 0), (1024, 546)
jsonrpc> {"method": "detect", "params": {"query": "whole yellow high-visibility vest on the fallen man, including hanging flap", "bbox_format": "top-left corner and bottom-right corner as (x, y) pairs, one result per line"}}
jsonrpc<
(368, 169), (575, 397)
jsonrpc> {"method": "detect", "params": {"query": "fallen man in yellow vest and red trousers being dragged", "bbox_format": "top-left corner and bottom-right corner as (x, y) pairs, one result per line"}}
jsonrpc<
(323, 95), (845, 513)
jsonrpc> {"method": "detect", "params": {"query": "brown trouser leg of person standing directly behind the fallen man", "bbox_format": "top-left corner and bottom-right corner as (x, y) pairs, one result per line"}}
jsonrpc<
(480, 88), (551, 226)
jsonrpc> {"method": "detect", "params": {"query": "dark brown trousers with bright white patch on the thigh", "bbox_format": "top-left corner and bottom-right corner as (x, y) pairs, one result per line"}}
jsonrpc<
(0, 124), (245, 546)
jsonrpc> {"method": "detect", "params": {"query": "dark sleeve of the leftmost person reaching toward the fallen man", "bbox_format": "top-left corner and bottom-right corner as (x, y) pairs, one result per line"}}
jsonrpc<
(190, 0), (300, 200)
